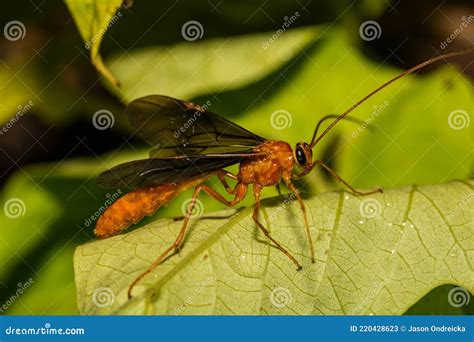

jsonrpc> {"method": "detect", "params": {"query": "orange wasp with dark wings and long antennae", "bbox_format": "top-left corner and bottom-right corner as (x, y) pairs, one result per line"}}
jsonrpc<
(94, 48), (474, 298)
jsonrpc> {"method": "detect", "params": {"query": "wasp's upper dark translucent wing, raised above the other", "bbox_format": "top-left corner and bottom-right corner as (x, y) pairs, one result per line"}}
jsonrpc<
(126, 95), (266, 158)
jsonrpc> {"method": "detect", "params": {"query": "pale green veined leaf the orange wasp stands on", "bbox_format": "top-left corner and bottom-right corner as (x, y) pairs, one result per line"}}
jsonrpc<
(74, 181), (474, 315)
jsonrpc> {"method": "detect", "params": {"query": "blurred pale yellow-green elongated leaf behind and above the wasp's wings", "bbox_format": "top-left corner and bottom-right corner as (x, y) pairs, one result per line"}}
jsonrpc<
(107, 26), (321, 102)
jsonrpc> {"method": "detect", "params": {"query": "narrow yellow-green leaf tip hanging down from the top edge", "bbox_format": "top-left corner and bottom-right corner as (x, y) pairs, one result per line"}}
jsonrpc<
(64, 0), (122, 86)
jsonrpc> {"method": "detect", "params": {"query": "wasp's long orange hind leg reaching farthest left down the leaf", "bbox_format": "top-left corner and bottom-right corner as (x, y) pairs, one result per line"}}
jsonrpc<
(127, 183), (247, 299)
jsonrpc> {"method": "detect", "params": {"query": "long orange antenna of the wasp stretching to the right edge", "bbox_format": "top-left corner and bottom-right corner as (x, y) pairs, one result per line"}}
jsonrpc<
(309, 48), (474, 148)
